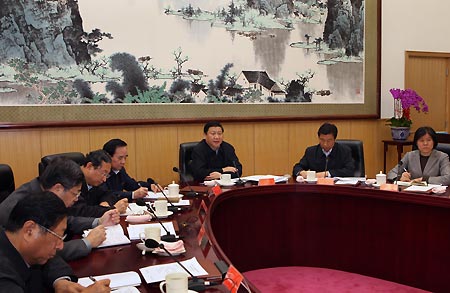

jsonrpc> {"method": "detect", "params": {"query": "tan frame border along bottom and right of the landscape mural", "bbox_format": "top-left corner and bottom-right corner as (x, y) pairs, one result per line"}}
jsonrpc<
(0, 0), (381, 127)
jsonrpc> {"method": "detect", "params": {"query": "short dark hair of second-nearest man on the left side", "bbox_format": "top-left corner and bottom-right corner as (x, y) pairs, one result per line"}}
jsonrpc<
(39, 157), (84, 190)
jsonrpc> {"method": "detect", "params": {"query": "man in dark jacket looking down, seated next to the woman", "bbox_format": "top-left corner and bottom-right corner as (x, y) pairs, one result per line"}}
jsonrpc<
(292, 123), (355, 178)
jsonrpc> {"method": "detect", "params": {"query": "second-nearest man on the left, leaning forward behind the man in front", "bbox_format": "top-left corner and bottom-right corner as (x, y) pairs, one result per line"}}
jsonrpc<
(0, 158), (120, 261)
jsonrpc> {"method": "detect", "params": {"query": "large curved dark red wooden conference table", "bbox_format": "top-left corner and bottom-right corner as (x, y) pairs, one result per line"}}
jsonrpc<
(70, 182), (450, 292)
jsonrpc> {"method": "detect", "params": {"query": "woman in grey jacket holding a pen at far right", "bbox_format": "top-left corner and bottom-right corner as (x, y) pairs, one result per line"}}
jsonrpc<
(387, 126), (450, 185)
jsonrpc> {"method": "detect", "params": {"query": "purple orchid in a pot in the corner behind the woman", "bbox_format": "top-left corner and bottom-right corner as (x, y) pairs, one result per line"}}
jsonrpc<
(387, 88), (428, 140)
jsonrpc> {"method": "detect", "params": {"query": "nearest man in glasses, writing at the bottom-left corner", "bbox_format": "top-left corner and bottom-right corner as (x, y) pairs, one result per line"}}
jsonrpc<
(0, 191), (110, 293)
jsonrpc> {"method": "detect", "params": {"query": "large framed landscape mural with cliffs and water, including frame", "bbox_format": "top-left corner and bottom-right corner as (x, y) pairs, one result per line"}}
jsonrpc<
(0, 0), (381, 123)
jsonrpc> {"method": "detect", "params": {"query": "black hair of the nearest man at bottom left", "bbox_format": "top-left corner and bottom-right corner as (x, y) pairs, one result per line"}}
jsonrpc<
(5, 191), (68, 232)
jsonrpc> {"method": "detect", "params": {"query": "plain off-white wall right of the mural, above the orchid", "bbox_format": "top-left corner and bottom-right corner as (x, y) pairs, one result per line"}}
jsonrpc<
(380, 0), (450, 118)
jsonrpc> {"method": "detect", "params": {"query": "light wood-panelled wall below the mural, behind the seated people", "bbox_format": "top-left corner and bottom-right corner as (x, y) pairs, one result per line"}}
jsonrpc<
(0, 120), (397, 185)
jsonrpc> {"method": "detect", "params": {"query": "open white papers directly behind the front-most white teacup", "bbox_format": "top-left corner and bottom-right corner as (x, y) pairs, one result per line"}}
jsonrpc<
(139, 257), (208, 283)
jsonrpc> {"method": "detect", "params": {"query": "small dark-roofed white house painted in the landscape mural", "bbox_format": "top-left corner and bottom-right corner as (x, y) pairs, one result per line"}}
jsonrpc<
(236, 71), (286, 99)
